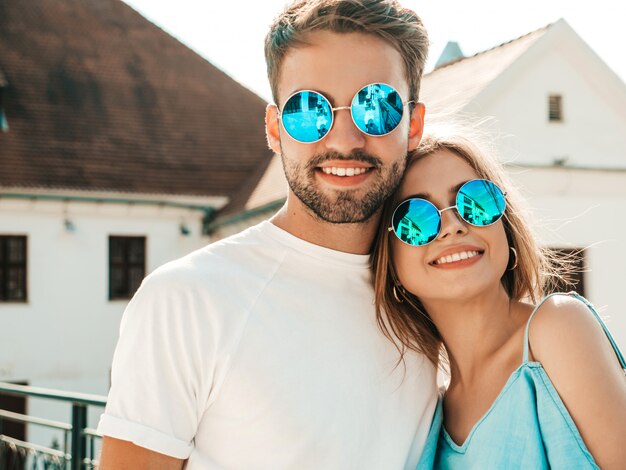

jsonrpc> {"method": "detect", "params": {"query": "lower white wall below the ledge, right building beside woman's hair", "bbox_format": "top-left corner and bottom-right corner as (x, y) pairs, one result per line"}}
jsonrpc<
(509, 168), (626, 350)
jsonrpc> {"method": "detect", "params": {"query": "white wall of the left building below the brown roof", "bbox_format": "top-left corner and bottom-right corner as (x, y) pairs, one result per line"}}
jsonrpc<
(0, 198), (209, 445)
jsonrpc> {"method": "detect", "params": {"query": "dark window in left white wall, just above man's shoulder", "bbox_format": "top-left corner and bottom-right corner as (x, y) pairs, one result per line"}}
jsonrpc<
(109, 236), (146, 300)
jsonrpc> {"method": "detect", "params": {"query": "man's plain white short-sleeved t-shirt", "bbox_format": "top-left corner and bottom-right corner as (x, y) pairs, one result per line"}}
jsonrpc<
(98, 222), (436, 470)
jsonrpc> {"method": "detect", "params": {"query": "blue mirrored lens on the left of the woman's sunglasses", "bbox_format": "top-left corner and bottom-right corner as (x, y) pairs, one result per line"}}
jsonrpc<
(392, 199), (441, 246)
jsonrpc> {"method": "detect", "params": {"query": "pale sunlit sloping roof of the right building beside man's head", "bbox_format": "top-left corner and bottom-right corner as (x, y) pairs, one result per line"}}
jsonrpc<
(420, 25), (550, 114)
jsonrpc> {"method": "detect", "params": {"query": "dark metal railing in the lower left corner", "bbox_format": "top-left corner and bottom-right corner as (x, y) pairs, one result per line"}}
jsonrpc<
(0, 382), (106, 470)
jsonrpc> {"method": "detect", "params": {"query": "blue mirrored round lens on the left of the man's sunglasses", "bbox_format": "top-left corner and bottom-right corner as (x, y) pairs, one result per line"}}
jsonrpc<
(281, 91), (333, 143)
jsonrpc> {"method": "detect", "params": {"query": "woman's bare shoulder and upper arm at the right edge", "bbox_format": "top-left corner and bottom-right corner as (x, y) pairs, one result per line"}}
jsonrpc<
(529, 296), (626, 470)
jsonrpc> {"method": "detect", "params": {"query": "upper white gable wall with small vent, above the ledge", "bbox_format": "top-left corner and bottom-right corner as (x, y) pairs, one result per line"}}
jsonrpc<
(464, 44), (626, 168)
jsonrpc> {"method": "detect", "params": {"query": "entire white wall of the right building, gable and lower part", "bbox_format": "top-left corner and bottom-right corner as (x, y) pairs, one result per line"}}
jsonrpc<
(464, 38), (626, 350)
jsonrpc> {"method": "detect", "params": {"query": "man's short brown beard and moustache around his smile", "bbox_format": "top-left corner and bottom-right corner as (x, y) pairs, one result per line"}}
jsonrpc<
(281, 151), (406, 224)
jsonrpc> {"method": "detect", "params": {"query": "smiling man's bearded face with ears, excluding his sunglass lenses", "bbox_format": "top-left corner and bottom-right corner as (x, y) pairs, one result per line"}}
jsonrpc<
(267, 31), (423, 223)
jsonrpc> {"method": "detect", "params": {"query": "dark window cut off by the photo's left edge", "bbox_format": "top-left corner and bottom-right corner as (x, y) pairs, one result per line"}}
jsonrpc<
(0, 235), (26, 302)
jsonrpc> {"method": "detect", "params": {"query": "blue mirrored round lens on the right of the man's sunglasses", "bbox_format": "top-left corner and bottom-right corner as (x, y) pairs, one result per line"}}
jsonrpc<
(352, 83), (403, 135)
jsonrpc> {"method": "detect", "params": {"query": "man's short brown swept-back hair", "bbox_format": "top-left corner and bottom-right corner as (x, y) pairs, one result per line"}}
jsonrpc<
(265, 0), (428, 105)
